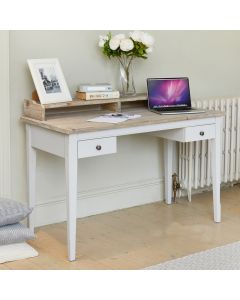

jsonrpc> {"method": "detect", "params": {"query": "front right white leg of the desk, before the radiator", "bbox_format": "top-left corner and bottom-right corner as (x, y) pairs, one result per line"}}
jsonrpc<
(211, 118), (221, 222)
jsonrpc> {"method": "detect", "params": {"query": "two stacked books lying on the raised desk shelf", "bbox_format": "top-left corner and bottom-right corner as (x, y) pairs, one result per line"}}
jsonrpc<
(76, 83), (120, 100)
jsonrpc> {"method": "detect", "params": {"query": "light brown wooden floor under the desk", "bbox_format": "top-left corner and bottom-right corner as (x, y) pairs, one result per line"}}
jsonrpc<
(0, 185), (240, 269)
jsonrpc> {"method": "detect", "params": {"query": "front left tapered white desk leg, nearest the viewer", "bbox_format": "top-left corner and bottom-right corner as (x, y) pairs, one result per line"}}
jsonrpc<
(65, 135), (78, 261)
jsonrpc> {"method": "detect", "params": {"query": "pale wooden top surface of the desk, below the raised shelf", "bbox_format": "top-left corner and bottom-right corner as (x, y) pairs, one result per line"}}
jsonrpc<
(21, 108), (224, 134)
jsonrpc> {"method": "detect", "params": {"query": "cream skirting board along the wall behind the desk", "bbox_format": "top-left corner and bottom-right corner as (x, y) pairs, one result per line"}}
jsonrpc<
(34, 178), (164, 226)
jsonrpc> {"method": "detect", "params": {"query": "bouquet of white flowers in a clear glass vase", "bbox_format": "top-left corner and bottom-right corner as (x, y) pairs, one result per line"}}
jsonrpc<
(98, 31), (154, 96)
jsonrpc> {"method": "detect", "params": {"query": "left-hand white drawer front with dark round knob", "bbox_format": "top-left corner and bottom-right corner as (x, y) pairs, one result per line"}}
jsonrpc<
(78, 137), (117, 158)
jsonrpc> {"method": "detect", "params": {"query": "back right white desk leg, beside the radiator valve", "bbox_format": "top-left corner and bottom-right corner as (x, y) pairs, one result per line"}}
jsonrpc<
(164, 139), (174, 204)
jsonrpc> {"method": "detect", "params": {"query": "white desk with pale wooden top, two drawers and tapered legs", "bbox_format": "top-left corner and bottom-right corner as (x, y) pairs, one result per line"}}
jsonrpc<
(21, 108), (223, 261)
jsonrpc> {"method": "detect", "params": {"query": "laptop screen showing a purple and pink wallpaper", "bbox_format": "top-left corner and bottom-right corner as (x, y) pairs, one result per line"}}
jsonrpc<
(148, 78), (191, 109)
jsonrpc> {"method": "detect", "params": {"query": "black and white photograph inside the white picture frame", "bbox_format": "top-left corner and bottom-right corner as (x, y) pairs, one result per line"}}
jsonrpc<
(39, 66), (61, 94)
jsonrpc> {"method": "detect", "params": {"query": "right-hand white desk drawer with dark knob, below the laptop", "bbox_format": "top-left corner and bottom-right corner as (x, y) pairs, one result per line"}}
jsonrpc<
(154, 124), (215, 142)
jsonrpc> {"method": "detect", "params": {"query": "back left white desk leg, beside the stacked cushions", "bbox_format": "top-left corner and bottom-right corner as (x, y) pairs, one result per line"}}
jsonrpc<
(26, 125), (36, 231)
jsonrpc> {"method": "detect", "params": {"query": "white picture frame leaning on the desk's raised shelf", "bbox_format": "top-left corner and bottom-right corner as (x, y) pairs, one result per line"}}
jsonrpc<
(27, 58), (72, 104)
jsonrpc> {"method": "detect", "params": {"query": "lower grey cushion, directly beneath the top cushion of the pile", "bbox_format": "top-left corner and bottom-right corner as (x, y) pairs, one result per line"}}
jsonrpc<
(0, 223), (35, 246)
